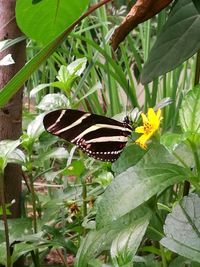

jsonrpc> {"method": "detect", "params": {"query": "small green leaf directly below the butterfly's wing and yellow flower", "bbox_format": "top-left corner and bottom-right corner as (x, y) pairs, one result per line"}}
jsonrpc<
(112, 145), (147, 174)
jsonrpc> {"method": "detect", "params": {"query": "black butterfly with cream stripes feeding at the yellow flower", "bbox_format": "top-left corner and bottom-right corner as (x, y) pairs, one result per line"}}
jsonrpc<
(43, 109), (132, 162)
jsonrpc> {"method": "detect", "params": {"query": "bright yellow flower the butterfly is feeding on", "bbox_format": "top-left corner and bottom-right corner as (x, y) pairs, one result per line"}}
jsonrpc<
(135, 108), (161, 149)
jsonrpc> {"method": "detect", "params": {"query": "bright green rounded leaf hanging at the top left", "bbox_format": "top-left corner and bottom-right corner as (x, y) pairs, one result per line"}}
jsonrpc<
(16, 0), (88, 44)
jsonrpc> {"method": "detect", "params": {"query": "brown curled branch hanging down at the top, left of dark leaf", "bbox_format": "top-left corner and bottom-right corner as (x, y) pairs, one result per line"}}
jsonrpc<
(111, 0), (173, 50)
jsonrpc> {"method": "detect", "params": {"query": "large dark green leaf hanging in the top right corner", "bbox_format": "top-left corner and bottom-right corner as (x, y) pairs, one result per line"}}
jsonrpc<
(141, 0), (200, 84)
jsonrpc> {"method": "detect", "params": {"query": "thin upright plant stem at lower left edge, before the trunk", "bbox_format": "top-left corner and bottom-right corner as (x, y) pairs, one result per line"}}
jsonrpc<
(0, 170), (12, 267)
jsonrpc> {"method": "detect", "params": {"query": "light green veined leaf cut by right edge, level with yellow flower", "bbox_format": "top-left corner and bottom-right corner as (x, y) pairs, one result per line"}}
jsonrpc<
(180, 85), (200, 134)
